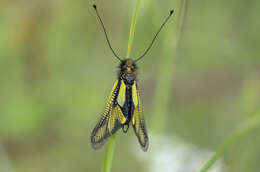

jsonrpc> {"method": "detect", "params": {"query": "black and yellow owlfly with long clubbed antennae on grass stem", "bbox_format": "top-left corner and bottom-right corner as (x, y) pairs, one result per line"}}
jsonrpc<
(91, 5), (174, 152)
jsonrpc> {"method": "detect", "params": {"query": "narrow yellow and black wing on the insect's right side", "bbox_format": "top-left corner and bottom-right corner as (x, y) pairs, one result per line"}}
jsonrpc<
(132, 81), (149, 152)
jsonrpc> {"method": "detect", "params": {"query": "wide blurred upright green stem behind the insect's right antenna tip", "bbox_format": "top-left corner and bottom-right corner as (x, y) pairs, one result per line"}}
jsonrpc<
(152, 0), (187, 133)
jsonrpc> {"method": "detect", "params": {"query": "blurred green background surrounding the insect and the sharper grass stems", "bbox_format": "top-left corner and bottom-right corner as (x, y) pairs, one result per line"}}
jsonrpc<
(0, 0), (260, 172)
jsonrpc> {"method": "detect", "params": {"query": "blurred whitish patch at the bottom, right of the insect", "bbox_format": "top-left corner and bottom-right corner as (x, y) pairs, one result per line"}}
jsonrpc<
(133, 133), (226, 172)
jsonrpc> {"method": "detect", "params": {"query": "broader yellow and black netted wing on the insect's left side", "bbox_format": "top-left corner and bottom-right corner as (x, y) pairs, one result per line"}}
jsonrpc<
(91, 80), (126, 149)
